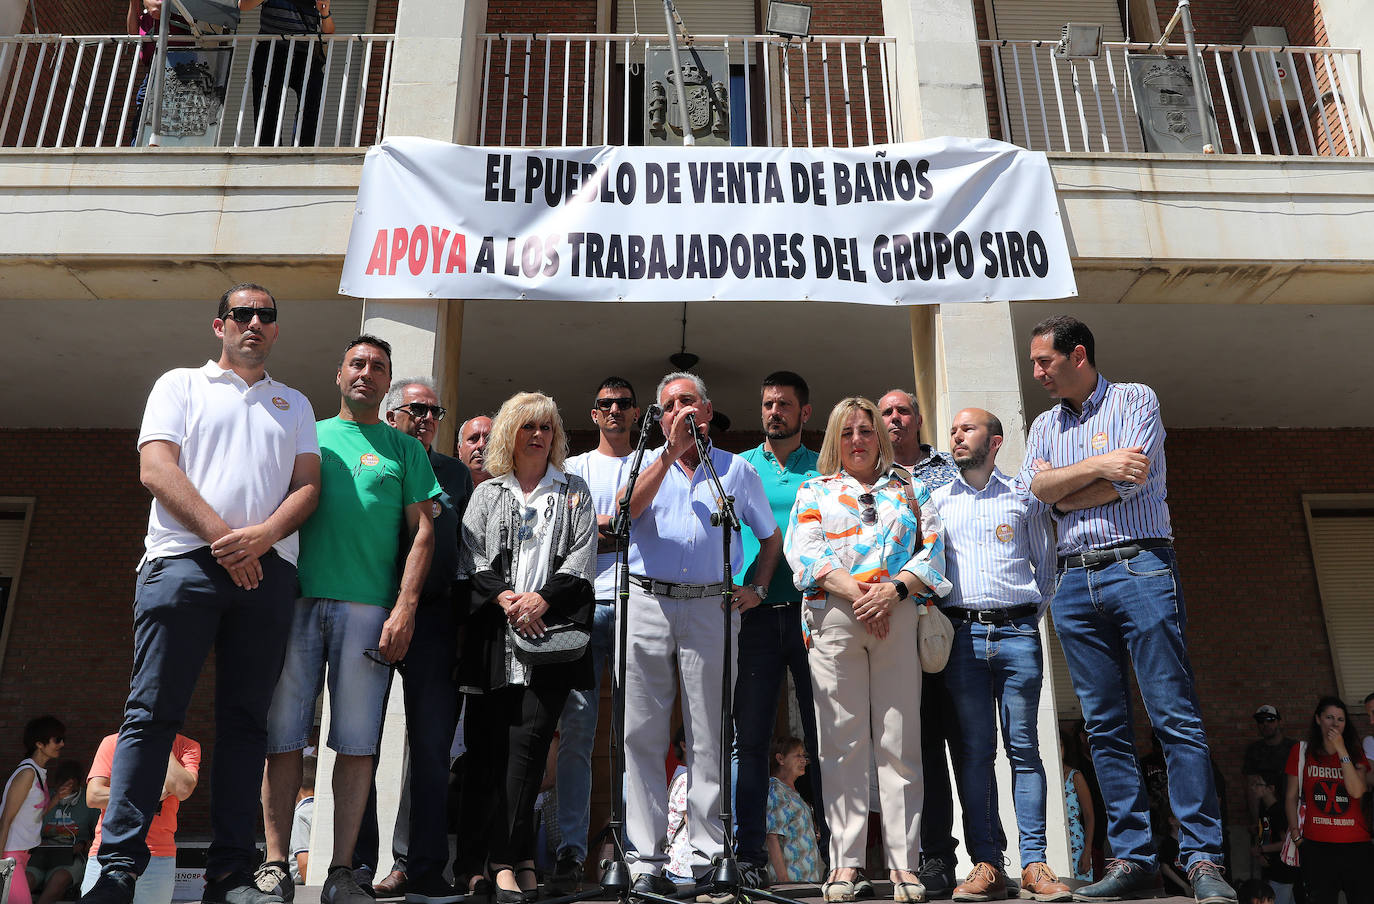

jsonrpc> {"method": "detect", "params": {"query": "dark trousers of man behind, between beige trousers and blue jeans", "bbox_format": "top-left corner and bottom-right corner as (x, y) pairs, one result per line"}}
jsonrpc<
(921, 673), (1007, 868)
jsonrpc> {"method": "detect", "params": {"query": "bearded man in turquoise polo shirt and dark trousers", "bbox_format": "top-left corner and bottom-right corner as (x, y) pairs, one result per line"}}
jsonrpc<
(735, 371), (830, 875)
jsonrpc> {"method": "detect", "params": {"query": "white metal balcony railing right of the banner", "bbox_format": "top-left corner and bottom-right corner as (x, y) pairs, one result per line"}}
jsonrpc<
(978, 40), (1374, 157)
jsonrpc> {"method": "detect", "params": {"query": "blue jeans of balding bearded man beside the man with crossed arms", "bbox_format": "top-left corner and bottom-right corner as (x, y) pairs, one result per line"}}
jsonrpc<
(944, 615), (1046, 868)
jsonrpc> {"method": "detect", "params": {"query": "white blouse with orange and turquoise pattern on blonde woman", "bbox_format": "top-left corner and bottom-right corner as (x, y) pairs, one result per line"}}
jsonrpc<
(783, 466), (952, 609)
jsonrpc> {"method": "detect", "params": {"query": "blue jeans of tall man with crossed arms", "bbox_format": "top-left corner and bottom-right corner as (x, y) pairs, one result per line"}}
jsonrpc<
(1052, 547), (1221, 870)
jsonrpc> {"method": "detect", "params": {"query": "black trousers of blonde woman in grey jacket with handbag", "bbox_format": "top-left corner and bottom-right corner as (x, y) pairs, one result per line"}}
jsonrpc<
(458, 677), (567, 875)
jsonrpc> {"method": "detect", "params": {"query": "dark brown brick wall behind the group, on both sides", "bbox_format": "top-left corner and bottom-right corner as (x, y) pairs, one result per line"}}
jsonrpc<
(0, 425), (1374, 838)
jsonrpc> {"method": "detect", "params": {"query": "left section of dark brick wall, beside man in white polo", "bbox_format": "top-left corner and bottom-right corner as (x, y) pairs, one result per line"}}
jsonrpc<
(0, 430), (214, 838)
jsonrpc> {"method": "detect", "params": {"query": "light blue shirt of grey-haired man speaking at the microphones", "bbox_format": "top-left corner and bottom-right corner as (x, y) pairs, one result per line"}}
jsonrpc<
(629, 447), (778, 584)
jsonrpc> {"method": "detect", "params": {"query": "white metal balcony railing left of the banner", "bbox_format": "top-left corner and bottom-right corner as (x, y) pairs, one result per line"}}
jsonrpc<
(0, 34), (394, 148)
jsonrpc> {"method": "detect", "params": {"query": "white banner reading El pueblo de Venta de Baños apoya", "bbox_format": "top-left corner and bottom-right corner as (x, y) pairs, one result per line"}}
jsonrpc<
(339, 137), (1077, 305)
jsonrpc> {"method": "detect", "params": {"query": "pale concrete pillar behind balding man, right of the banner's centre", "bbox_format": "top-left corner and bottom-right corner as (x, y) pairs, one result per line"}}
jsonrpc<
(882, 0), (1070, 875)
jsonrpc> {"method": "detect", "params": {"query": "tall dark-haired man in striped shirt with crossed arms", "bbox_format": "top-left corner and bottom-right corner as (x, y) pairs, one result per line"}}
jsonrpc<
(1020, 315), (1235, 904)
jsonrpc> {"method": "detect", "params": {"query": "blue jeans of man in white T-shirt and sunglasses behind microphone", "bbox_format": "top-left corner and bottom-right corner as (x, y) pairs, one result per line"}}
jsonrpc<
(558, 599), (616, 861)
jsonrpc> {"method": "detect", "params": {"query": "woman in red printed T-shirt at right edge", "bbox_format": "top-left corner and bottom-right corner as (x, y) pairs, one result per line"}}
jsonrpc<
(1287, 697), (1374, 904)
